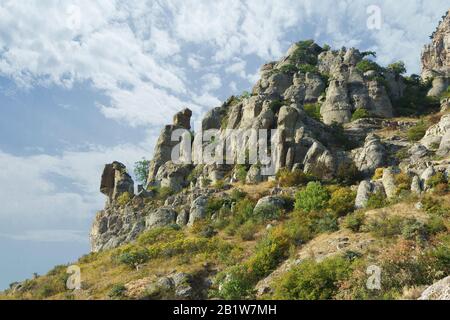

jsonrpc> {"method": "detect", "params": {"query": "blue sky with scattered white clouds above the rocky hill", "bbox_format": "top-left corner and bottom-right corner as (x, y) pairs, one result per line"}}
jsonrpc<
(0, 0), (449, 290)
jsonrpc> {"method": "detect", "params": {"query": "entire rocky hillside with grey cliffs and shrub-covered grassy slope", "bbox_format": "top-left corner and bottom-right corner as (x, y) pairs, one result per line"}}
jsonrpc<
(0, 13), (450, 299)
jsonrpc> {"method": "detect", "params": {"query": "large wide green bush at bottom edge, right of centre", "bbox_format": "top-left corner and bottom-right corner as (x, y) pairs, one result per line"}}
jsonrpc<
(274, 257), (352, 300)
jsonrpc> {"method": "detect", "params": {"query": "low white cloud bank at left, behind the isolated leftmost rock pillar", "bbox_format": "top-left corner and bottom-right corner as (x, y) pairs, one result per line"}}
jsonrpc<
(0, 141), (150, 233)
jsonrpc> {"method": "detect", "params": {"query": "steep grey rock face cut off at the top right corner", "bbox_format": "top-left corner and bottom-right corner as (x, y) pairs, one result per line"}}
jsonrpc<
(422, 11), (450, 97)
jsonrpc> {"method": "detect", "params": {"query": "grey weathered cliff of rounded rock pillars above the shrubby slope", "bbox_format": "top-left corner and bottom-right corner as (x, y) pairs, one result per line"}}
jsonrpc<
(91, 21), (450, 251)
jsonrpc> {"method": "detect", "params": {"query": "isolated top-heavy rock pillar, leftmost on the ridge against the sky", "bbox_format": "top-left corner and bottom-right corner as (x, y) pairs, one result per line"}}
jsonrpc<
(100, 162), (134, 203)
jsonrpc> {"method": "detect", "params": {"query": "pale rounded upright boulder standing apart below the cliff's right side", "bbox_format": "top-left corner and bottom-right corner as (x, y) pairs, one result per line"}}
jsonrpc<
(352, 134), (386, 176)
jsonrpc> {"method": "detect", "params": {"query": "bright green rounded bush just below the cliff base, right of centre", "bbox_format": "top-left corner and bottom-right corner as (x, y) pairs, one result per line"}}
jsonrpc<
(295, 182), (330, 212)
